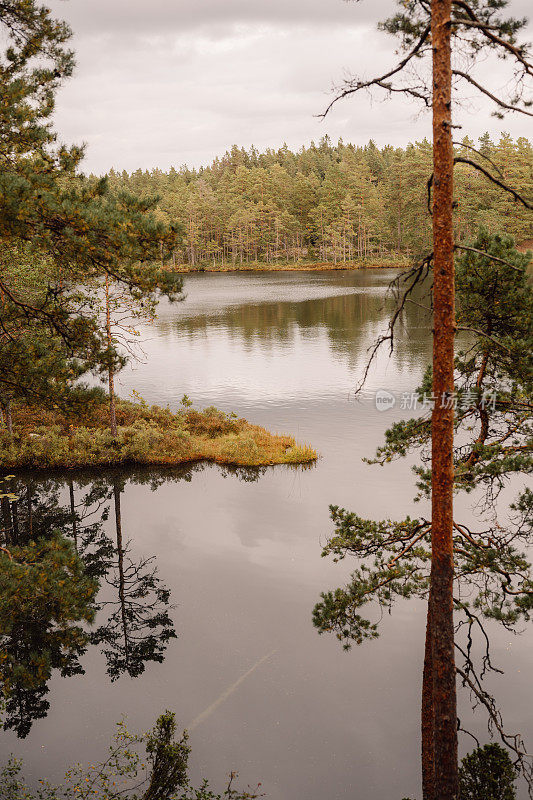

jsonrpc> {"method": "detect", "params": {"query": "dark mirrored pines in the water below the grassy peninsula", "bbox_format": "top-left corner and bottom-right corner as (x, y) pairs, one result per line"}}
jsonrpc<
(0, 470), (181, 738)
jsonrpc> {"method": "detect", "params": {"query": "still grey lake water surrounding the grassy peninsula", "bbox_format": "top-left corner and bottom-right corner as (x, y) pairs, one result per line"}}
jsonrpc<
(4, 270), (533, 800)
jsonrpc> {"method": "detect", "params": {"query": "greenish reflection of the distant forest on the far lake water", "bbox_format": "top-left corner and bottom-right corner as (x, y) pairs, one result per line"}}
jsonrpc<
(152, 270), (428, 378)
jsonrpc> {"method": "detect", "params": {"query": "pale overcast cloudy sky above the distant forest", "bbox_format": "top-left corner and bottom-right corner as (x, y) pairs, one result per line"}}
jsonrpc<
(50, 0), (533, 173)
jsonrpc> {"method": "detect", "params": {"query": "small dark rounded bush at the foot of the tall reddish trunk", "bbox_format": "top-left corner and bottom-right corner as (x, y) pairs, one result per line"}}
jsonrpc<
(459, 743), (517, 800)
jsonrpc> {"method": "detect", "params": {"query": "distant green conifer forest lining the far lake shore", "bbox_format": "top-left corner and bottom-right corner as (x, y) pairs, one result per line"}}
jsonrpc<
(109, 134), (533, 267)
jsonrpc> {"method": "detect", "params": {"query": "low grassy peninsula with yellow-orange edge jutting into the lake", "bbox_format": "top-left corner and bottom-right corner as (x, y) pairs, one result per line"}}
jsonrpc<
(0, 399), (317, 470)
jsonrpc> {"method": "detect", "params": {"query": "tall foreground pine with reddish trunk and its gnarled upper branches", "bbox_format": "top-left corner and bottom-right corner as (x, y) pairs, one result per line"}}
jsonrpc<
(320, 0), (533, 800)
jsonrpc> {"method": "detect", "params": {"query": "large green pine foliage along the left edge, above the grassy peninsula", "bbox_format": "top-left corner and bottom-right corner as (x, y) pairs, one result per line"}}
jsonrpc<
(0, 0), (181, 412)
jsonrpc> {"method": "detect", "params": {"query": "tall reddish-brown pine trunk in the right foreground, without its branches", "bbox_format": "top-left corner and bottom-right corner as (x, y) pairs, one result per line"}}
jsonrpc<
(429, 0), (459, 800)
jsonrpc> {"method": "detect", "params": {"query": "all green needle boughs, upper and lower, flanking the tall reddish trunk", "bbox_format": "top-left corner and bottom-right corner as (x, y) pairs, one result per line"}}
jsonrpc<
(313, 230), (533, 647)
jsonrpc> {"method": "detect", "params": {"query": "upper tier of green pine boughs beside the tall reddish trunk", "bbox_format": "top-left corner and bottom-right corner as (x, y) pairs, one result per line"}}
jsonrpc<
(374, 229), (533, 502)
